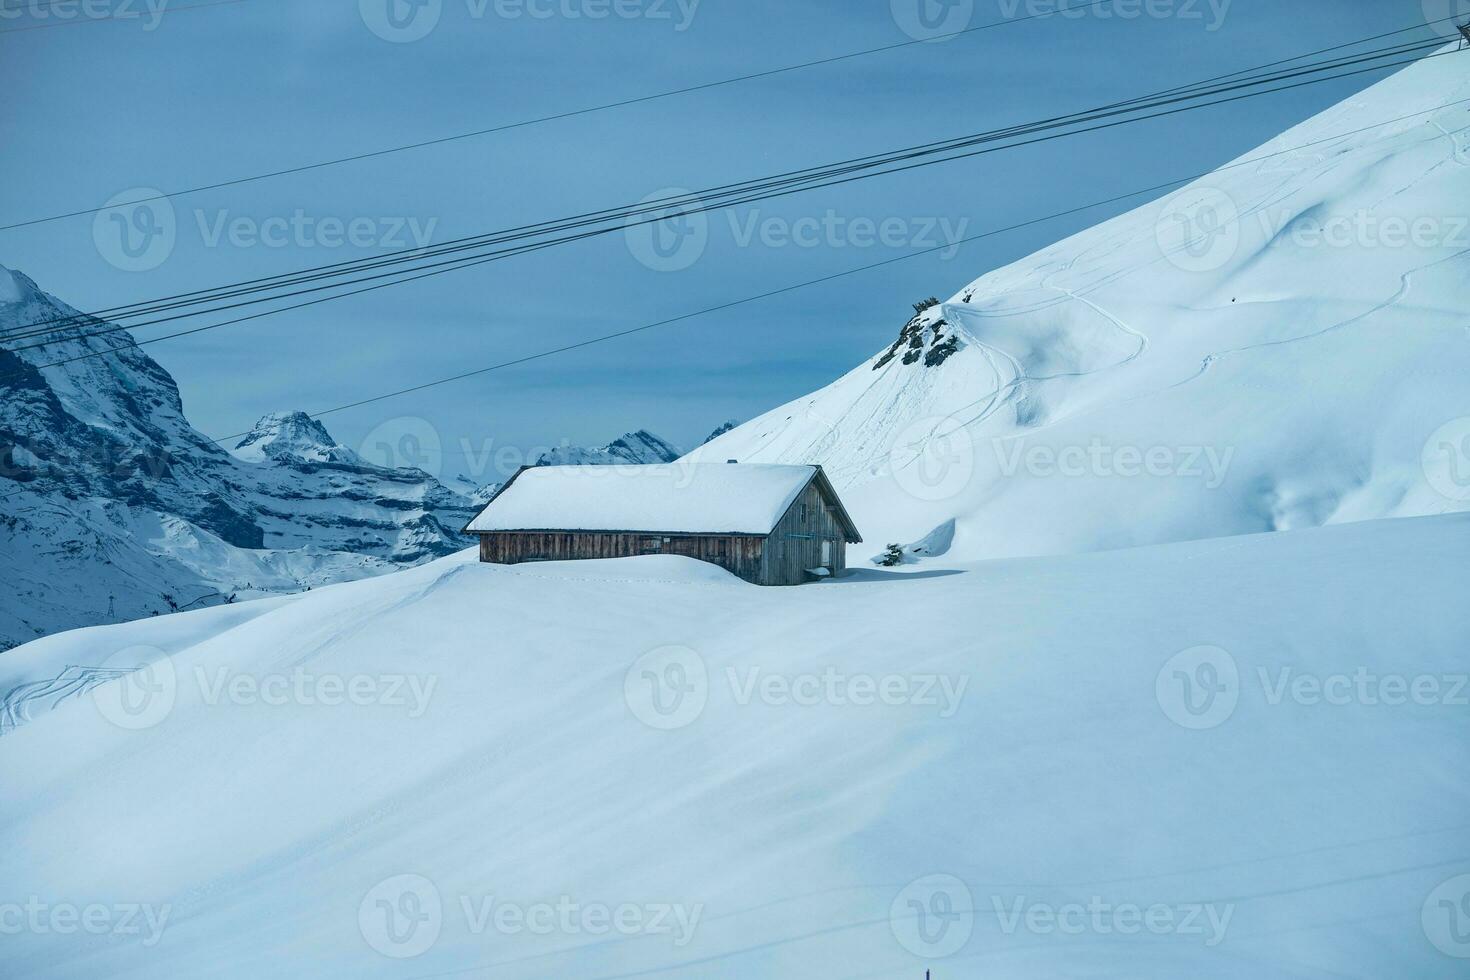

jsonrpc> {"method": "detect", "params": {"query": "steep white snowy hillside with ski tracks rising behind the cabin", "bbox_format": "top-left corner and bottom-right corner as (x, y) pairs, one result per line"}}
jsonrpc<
(692, 54), (1470, 558)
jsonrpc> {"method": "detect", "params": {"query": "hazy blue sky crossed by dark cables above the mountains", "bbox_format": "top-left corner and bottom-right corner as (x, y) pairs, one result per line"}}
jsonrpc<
(0, 0), (1446, 479)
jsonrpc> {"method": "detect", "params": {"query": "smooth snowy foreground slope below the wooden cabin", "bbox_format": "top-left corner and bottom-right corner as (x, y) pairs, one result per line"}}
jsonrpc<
(0, 514), (1470, 980)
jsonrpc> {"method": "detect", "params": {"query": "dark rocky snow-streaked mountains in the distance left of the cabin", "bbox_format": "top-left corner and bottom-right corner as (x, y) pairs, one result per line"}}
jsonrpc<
(0, 269), (473, 649)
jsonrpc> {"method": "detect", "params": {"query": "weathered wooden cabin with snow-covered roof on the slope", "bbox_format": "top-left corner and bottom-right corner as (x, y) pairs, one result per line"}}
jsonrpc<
(465, 463), (863, 585)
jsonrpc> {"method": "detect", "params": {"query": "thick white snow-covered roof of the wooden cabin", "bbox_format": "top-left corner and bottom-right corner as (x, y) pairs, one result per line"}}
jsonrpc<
(465, 463), (840, 535)
